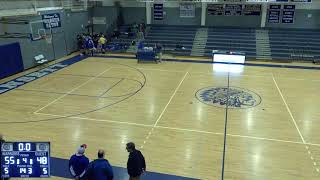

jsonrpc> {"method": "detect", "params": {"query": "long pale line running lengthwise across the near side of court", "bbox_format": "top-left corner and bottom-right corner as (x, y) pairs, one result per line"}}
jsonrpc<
(35, 112), (320, 147)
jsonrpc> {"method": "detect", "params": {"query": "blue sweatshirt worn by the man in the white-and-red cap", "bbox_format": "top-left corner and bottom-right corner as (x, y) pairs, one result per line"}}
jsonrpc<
(69, 154), (89, 177)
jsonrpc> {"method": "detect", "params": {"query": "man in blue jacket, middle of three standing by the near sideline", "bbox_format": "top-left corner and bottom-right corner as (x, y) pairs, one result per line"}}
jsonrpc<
(85, 149), (113, 180)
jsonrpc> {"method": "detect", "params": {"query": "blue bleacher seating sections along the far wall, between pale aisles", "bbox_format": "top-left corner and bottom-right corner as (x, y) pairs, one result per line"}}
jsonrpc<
(132, 25), (320, 60)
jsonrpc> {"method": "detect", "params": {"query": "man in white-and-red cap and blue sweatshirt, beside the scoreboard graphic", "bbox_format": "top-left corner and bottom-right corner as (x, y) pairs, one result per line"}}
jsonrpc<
(69, 144), (89, 179)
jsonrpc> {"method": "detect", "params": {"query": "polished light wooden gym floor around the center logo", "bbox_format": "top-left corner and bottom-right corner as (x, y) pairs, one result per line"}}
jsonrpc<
(0, 55), (320, 180)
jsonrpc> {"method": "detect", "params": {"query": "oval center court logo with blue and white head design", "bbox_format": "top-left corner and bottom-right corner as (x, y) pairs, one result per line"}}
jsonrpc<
(196, 87), (261, 108)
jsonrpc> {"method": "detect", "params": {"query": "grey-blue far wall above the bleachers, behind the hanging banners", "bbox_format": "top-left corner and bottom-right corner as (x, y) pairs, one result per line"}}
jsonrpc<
(117, 1), (320, 29)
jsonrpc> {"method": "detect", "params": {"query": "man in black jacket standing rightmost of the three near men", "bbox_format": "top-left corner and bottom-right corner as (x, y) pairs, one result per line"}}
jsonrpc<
(126, 142), (146, 180)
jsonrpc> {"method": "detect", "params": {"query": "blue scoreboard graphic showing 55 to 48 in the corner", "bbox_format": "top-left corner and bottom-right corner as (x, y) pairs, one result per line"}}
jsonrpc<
(1, 142), (50, 178)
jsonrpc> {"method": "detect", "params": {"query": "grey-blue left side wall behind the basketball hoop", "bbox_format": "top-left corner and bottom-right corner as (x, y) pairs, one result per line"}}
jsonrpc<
(0, 10), (89, 69)
